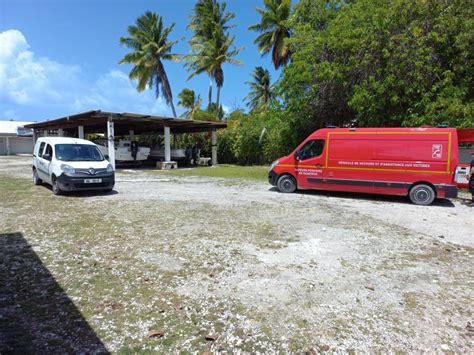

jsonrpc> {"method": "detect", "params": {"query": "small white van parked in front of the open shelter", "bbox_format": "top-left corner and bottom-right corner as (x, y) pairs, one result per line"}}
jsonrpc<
(33, 137), (115, 195)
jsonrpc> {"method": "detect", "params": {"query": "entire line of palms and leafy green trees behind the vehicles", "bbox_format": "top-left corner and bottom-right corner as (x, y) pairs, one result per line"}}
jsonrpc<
(121, 0), (474, 164)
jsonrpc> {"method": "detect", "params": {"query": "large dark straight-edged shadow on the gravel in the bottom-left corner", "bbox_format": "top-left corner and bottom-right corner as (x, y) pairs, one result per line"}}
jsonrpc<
(0, 233), (108, 354)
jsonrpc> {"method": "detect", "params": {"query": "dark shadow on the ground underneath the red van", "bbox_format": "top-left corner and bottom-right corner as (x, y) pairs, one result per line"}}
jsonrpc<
(270, 187), (455, 207)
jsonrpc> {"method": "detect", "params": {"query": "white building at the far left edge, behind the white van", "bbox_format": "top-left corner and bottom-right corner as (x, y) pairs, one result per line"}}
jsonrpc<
(0, 121), (34, 155)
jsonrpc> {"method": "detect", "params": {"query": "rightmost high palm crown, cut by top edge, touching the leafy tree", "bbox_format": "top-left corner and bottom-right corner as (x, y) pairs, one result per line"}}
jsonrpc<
(249, 0), (291, 69)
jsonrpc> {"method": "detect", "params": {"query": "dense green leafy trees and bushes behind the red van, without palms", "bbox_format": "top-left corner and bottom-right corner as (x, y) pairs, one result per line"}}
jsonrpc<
(223, 0), (474, 164)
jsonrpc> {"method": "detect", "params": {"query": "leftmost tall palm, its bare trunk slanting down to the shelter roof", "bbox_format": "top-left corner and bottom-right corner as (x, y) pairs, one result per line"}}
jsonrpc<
(119, 11), (178, 117)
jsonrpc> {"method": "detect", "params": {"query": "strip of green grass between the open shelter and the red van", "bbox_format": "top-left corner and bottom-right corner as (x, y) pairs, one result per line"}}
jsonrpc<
(149, 165), (268, 181)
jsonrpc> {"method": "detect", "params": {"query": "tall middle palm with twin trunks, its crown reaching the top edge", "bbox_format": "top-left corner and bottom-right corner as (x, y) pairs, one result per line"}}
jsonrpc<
(186, 0), (242, 107)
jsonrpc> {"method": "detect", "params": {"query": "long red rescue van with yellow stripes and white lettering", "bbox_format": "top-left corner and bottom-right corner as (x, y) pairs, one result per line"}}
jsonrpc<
(269, 127), (458, 205)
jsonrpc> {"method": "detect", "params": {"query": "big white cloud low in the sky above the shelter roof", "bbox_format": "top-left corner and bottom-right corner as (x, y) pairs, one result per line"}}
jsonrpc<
(0, 30), (170, 115)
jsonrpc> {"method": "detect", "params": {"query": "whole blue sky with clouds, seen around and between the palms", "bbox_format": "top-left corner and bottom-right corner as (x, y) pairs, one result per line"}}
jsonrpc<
(0, 0), (279, 121)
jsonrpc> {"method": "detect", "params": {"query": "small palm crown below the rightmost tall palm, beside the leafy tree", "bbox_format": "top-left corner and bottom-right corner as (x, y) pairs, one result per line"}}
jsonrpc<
(245, 67), (275, 111)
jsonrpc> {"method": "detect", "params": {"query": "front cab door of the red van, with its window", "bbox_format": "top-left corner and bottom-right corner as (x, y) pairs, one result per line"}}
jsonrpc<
(295, 139), (326, 190)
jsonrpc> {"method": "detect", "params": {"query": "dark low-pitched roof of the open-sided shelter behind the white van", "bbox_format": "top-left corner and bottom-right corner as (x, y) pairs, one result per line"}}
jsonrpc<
(25, 110), (227, 135)
